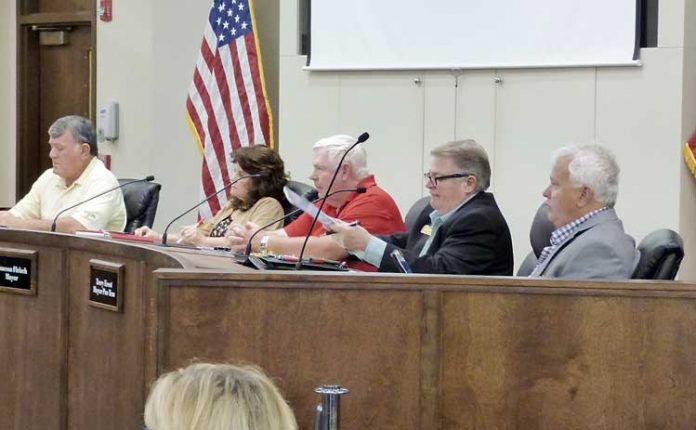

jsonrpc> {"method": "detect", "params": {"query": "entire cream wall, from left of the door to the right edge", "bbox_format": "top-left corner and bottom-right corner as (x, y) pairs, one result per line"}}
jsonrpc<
(0, 0), (696, 279)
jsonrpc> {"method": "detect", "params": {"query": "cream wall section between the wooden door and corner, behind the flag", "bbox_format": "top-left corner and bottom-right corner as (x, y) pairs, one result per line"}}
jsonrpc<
(97, 0), (278, 230)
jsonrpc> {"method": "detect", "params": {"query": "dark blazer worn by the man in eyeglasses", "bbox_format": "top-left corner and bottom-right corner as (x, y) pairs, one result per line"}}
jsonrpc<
(379, 192), (513, 276)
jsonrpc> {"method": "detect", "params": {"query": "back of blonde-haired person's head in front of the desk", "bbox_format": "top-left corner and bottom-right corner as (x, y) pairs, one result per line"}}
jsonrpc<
(145, 363), (297, 430)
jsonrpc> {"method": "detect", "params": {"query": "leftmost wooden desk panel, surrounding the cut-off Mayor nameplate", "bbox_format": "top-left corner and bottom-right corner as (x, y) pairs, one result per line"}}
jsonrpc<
(0, 241), (67, 430)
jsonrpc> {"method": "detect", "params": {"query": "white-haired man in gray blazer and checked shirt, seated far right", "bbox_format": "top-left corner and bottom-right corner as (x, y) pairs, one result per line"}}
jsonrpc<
(530, 145), (639, 279)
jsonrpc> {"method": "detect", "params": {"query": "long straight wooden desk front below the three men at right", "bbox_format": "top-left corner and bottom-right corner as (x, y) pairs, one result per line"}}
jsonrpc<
(158, 270), (696, 430)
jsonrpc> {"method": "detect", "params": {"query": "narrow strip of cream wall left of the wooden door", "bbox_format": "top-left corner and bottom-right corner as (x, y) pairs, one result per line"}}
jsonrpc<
(0, 0), (17, 207)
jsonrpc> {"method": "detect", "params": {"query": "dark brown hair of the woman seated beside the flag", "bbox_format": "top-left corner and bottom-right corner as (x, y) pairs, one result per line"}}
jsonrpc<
(231, 145), (288, 210)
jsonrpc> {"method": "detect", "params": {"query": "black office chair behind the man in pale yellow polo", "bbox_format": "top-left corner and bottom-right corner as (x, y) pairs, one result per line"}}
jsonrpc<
(118, 179), (162, 233)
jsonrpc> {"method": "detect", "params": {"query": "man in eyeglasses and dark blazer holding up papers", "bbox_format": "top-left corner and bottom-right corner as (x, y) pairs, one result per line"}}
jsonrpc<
(332, 140), (513, 275)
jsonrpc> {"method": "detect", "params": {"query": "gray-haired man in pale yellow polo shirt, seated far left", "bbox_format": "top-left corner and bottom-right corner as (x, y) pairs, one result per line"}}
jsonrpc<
(0, 115), (126, 233)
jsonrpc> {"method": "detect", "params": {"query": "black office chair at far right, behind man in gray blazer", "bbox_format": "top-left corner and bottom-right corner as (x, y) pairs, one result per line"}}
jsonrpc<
(631, 228), (684, 280)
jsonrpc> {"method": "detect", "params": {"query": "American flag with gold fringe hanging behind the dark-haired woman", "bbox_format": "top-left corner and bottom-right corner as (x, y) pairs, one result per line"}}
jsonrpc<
(186, 0), (273, 219)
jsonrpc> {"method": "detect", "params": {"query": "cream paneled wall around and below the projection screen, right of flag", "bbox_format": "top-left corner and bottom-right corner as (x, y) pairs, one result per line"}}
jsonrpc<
(280, 0), (696, 279)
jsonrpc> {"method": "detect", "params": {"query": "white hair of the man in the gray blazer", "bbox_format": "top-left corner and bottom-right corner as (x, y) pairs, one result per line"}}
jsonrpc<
(552, 144), (620, 208)
